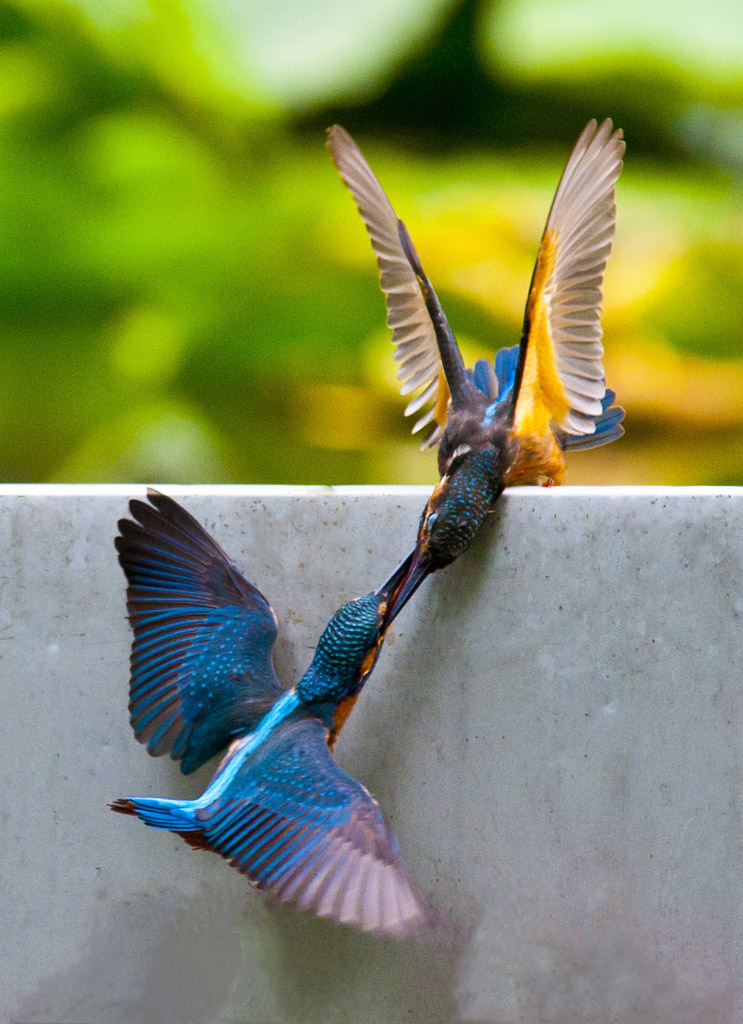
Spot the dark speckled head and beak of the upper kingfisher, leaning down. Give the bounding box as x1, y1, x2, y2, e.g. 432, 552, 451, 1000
385, 444, 505, 628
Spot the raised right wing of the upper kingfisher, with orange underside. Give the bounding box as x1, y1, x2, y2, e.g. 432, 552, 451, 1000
514, 119, 624, 435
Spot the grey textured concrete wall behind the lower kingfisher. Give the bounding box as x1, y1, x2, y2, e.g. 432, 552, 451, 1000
0, 487, 743, 1024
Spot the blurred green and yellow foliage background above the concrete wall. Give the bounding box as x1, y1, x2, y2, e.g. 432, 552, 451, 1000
0, 0, 743, 483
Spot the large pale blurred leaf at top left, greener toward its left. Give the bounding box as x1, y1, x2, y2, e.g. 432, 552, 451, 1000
46, 0, 451, 108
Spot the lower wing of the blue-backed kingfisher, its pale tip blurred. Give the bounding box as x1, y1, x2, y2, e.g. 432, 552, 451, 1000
197, 718, 428, 935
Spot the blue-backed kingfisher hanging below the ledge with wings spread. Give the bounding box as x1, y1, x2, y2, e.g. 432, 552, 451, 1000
110, 490, 431, 936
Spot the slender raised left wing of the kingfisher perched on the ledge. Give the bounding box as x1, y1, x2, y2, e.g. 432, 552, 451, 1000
327, 125, 449, 447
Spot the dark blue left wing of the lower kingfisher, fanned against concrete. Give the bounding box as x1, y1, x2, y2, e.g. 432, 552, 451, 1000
116, 490, 283, 774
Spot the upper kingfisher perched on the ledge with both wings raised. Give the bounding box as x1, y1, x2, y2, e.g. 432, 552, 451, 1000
327, 119, 624, 613
